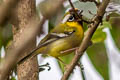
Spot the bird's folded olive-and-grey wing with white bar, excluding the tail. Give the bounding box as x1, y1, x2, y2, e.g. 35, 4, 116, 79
38, 24, 72, 46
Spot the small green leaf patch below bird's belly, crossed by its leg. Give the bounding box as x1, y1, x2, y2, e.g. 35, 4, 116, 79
58, 53, 74, 72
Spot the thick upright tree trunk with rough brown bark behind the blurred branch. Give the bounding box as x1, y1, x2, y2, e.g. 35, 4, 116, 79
11, 0, 38, 80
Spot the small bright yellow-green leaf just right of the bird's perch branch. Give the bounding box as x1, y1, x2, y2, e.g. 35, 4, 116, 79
92, 29, 106, 43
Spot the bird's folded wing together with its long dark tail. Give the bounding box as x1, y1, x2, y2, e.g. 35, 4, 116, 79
18, 24, 73, 64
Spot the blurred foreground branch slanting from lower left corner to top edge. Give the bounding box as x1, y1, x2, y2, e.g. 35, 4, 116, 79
0, 0, 64, 80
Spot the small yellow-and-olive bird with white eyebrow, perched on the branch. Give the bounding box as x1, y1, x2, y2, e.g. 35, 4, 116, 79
18, 9, 84, 63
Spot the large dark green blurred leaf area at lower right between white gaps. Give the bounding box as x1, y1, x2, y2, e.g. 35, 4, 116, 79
87, 43, 109, 80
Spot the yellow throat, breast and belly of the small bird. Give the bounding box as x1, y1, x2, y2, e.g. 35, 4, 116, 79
46, 22, 84, 57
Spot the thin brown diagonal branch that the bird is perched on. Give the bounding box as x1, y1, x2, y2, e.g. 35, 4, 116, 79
61, 0, 110, 80
